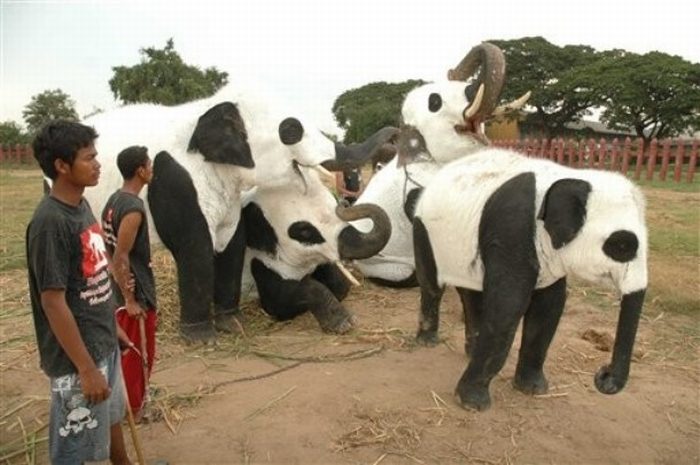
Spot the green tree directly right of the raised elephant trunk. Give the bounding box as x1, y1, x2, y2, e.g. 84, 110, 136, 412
489, 37, 600, 137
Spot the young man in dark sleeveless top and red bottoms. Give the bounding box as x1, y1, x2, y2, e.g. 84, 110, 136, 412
102, 146, 156, 418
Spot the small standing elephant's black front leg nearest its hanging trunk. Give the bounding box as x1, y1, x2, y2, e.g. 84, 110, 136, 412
513, 278, 566, 394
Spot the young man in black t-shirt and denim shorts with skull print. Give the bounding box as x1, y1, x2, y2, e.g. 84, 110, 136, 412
26, 120, 131, 465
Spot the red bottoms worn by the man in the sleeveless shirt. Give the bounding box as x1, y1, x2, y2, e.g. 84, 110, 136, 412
116, 307, 158, 415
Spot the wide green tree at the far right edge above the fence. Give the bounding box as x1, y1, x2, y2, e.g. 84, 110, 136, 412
569, 52, 700, 146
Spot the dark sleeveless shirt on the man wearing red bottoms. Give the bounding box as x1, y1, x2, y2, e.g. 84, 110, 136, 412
102, 190, 156, 309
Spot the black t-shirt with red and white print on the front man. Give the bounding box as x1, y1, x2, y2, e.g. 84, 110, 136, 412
26, 195, 117, 377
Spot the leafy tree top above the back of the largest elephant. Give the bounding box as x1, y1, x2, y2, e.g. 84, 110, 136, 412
109, 39, 228, 105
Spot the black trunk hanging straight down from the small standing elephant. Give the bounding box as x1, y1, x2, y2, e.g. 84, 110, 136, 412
595, 289, 646, 394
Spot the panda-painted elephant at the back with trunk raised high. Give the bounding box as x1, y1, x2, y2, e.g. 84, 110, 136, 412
357, 42, 529, 287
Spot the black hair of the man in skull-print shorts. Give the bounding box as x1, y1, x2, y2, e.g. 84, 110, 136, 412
32, 119, 98, 179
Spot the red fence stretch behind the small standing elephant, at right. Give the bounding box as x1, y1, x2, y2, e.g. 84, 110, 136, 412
494, 137, 700, 182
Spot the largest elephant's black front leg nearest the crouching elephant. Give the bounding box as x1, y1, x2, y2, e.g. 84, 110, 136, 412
214, 221, 245, 333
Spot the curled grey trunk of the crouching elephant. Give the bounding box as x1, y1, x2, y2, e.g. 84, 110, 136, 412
335, 204, 391, 260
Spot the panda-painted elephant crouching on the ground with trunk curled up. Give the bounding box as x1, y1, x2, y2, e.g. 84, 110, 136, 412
243, 169, 391, 333
